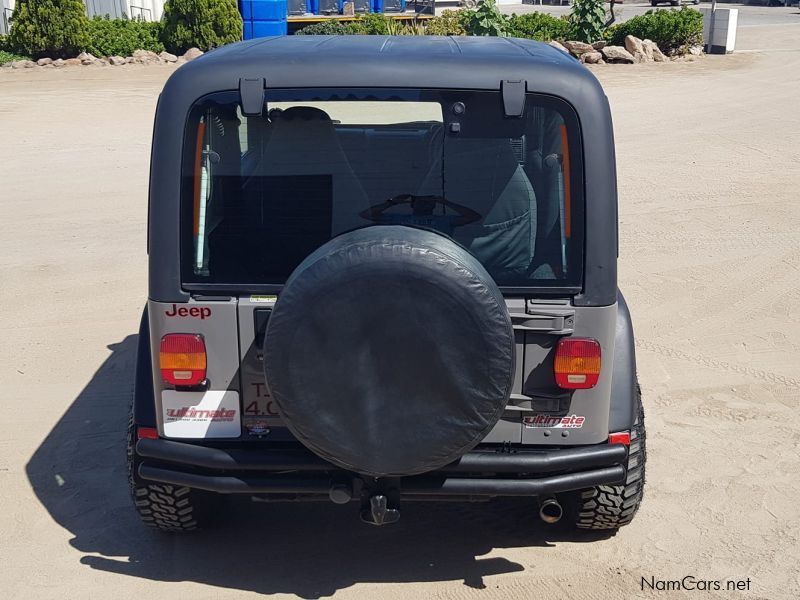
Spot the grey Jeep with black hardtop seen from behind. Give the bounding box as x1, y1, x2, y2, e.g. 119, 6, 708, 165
128, 36, 645, 531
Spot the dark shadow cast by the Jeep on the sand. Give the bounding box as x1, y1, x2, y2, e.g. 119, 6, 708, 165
26, 335, 605, 598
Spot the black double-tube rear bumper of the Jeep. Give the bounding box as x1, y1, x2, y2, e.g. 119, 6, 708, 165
136, 439, 628, 498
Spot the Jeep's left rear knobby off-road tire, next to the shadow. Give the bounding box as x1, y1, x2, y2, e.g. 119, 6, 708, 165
127, 416, 222, 533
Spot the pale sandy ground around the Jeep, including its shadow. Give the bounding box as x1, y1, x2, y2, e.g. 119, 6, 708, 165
0, 19, 800, 600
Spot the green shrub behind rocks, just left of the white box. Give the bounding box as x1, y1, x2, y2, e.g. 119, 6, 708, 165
609, 6, 703, 53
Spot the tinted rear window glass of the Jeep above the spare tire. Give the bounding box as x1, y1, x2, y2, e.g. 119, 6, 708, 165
181, 89, 583, 290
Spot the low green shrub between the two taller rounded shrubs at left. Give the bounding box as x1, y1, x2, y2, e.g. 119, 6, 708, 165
87, 17, 164, 56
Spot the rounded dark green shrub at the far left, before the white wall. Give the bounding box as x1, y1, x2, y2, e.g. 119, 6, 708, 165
8, 0, 89, 58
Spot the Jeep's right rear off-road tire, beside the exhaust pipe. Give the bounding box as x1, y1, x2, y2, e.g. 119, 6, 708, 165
571, 384, 647, 530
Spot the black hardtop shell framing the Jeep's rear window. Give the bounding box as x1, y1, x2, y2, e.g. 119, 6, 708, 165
149, 35, 617, 306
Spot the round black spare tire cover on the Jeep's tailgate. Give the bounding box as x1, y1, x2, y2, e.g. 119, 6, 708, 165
264, 225, 514, 477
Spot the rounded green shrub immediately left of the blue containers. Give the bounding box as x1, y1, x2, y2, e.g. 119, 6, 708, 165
161, 0, 242, 54
